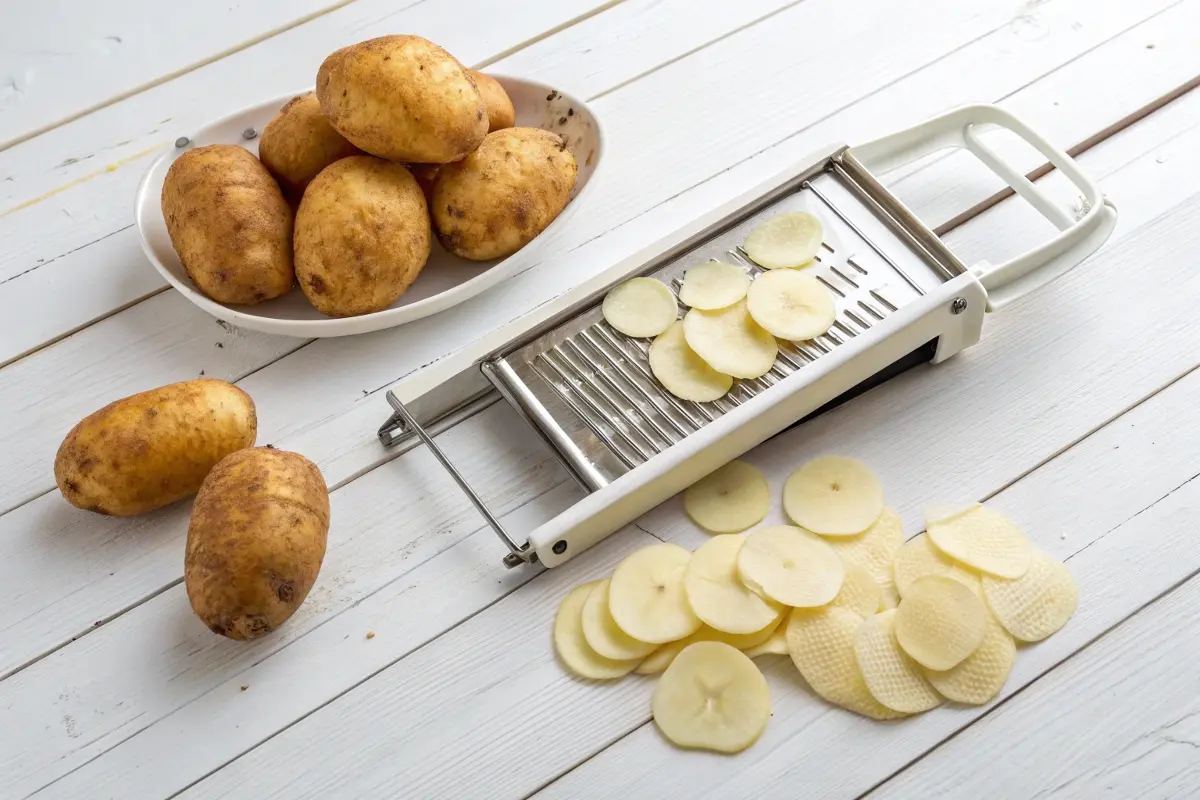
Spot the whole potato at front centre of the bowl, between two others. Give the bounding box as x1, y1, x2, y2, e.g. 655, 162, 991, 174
295, 156, 431, 317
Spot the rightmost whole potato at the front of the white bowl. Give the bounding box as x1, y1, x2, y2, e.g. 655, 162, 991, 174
432, 128, 578, 261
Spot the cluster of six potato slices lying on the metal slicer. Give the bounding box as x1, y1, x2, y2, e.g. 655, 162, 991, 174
602, 211, 836, 403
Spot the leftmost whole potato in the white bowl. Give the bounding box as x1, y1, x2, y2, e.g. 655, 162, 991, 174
162, 144, 295, 305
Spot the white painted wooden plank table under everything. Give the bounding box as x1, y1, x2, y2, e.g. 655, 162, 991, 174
0, 0, 1200, 799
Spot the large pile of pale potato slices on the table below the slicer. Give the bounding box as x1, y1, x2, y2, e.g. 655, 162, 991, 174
553, 456, 1079, 753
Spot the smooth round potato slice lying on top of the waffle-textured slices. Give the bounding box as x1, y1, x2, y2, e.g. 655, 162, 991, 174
895, 575, 988, 669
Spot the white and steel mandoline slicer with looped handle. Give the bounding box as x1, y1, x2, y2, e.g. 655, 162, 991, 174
379, 106, 1116, 566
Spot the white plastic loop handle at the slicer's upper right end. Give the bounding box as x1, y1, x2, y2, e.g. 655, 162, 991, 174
851, 100, 1117, 311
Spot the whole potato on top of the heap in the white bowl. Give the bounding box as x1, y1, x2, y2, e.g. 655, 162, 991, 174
317, 36, 487, 164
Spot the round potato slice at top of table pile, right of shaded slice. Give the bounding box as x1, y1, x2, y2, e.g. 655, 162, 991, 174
784, 456, 883, 536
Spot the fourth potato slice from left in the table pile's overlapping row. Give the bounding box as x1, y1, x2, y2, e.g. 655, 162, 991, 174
684, 534, 782, 633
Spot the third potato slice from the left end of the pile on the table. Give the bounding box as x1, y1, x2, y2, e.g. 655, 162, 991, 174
608, 543, 701, 643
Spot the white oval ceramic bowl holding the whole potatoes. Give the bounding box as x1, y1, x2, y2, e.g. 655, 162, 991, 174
134, 76, 604, 337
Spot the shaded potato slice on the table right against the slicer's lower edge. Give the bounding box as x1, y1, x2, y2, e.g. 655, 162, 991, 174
683, 461, 770, 534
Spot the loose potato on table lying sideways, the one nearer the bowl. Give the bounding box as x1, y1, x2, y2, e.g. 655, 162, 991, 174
54, 378, 258, 517
